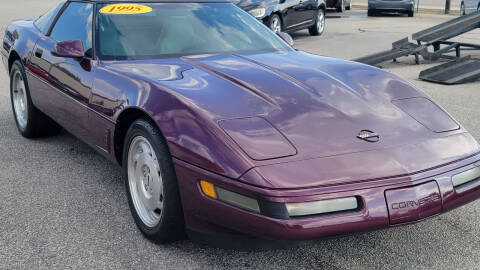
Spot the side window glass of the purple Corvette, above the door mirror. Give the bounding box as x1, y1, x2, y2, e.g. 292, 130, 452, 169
50, 2, 93, 57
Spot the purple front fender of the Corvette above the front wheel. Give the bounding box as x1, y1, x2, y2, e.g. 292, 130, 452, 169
91, 65, 253, 178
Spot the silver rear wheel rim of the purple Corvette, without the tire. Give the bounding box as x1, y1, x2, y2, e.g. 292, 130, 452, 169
12, 70, 28, 130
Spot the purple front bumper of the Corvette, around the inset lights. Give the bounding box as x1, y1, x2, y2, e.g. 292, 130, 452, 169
175, 155, 480, 241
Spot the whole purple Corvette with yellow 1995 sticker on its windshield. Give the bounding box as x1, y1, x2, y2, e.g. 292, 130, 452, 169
1, 0, 480, 247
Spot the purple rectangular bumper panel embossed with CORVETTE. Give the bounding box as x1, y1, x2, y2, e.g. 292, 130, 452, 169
385, 181, 442, 225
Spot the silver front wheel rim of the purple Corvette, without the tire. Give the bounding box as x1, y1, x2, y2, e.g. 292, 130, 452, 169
127, 136, 164, 228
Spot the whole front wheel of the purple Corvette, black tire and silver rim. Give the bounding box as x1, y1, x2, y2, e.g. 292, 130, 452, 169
122, 119, 185, 244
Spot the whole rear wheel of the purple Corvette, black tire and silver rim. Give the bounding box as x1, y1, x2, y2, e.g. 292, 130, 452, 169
10, 60, 62, 139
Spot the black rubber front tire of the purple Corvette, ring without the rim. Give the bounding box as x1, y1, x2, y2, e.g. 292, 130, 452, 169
122, 120, 183, 242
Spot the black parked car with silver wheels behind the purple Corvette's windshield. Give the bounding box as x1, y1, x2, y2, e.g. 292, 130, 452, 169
237, 0, 326, 36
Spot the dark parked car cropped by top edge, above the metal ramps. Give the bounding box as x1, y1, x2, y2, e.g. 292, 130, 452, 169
368, 0, 415, 17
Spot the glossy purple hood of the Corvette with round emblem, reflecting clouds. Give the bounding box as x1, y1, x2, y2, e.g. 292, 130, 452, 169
102, 51, 476, 186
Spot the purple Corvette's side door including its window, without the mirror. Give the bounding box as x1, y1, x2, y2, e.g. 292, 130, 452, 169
30, 2, 95, 140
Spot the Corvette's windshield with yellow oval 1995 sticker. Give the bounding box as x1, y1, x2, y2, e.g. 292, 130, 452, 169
96, 3, 292, 60
